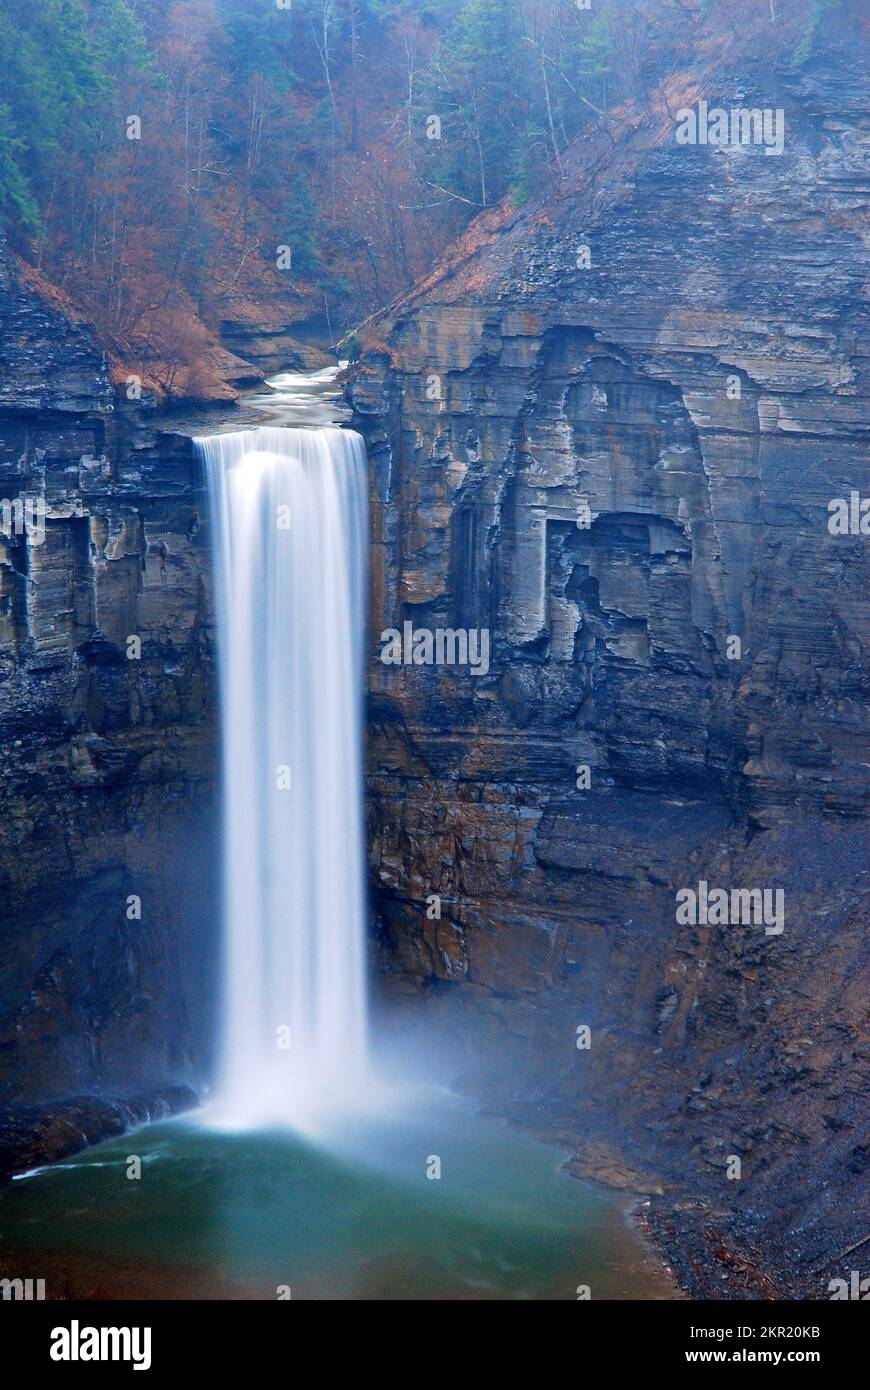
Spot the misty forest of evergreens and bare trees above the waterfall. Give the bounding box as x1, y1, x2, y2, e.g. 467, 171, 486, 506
0, 0, 837, 391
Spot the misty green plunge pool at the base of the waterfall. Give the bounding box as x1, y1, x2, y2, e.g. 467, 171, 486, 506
0, 1095, 671, 1300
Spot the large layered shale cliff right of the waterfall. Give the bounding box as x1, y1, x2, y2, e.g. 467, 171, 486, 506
352, 35, 870, 1297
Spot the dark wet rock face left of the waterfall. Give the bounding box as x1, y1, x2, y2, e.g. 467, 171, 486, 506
0, 241, 215, 1101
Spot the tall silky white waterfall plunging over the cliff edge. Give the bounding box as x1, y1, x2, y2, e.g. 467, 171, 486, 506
196, 427, 367, 1127
